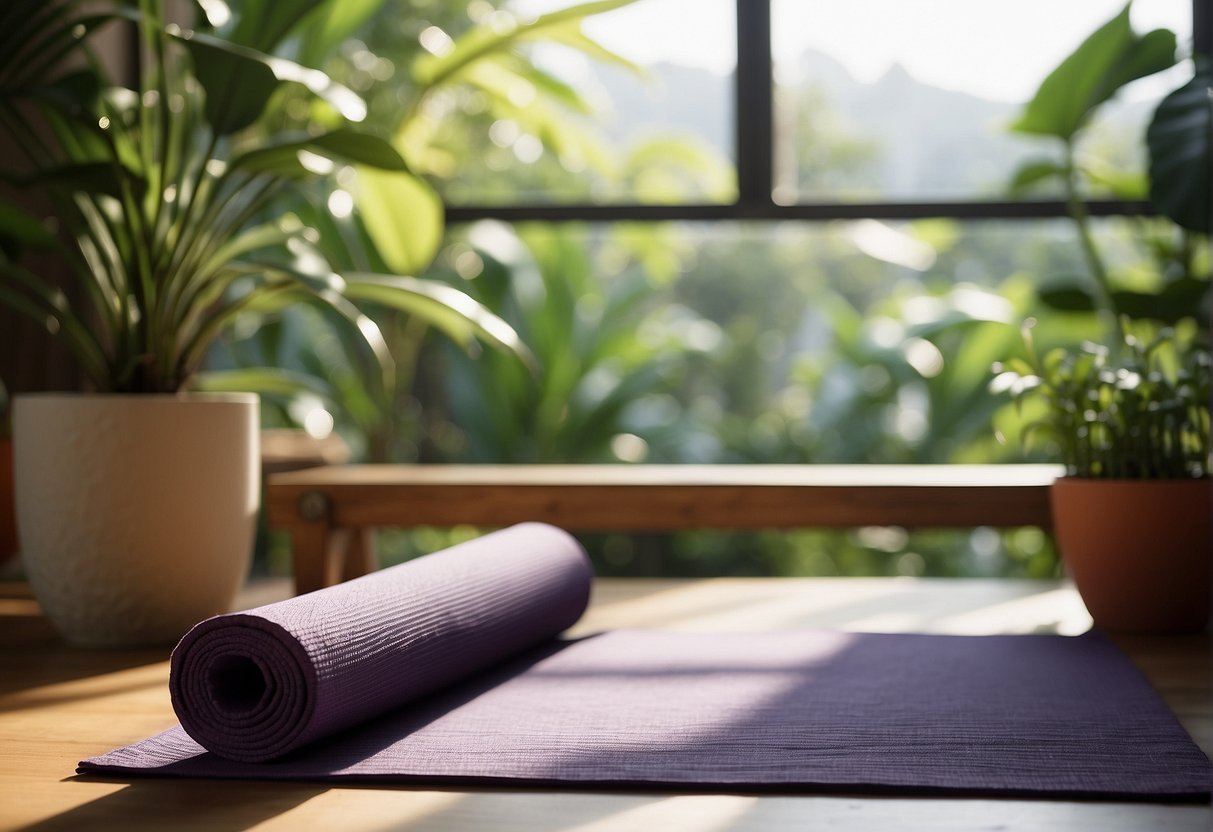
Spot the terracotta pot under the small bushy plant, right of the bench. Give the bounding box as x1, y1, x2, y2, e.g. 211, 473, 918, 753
1050, 477, 1213, 633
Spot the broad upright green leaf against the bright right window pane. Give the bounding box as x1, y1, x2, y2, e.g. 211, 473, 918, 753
1012, 4, 1175, 141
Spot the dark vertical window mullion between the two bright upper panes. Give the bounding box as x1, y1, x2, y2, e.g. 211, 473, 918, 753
734, 0, 774, 206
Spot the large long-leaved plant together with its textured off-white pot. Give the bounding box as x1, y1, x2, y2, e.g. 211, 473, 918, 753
0, 0, 524, 645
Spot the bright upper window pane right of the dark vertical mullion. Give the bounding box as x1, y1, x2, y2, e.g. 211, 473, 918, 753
771, 0, 1191, 203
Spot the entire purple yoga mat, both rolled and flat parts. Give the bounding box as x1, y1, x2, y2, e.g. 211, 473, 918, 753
79, 524, 1213, 800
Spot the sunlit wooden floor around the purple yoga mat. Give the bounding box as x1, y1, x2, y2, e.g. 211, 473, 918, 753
0, 579, 1213, 832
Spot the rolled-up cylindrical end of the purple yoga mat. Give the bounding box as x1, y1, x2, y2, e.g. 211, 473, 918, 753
169, 524, 592, 763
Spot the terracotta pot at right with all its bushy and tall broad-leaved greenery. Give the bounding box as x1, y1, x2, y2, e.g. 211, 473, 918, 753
995, 6, 1213, 632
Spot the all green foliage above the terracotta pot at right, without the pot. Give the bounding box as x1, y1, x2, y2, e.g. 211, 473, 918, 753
993, 4, 1213, 479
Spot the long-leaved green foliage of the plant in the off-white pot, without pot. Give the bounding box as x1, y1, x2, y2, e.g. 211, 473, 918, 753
0, 0, 524, 392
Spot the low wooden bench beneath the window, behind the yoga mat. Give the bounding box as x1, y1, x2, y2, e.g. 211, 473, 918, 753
266, 465, 1060, 593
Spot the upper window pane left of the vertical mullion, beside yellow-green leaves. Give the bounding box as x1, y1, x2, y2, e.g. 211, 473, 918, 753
432, 0, 736, 205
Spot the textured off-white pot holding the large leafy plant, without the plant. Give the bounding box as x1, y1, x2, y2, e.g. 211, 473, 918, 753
13, 393, 260, 646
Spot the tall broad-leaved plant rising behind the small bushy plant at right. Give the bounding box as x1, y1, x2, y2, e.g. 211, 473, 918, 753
1012, 2, 1213, 337
